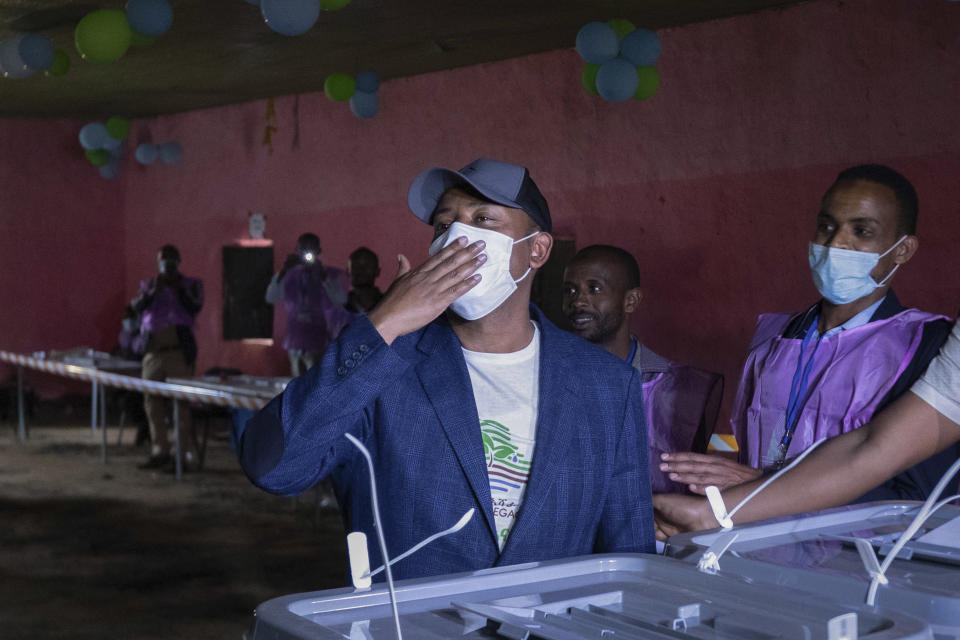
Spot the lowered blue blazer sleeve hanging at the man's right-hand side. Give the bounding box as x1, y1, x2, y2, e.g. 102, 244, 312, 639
595, 371, 655, 553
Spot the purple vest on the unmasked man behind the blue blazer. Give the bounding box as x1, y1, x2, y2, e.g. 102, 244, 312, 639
641, 362, 720, 493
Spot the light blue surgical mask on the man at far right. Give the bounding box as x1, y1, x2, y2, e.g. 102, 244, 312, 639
810, 236, 907, 304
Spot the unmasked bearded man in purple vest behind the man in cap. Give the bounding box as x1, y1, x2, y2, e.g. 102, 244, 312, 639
562, 244, 723, 493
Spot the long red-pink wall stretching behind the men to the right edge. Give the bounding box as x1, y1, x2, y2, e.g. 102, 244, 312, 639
0, 0, 960, 416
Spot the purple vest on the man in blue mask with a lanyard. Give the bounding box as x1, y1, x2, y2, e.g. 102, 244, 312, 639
730, 309, 944, 468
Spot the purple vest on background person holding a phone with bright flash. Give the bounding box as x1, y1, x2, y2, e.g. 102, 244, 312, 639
283, 265, 353, 352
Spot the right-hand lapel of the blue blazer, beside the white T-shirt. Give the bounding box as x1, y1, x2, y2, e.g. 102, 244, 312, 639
500, 307, 576, 563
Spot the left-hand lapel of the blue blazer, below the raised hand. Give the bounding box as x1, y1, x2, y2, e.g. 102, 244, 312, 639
415, 321, 497, 545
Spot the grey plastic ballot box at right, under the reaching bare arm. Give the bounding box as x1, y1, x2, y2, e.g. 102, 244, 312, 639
666, 502, 960, 640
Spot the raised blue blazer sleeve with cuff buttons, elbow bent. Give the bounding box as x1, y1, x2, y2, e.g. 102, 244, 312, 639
239, 317, 411, 496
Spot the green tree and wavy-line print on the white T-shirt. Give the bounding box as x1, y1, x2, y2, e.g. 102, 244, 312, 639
480, 420, 533, 549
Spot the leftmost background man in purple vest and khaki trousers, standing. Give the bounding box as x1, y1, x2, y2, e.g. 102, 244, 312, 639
130, 244, 203, 470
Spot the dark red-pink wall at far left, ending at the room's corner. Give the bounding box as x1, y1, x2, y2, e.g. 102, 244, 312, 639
0, 116, 126, 395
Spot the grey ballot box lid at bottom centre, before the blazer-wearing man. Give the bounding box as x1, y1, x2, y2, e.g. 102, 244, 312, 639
246, 554, 931, 640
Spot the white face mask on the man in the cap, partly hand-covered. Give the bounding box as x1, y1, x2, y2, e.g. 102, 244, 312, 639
430, 222, 540, 320
